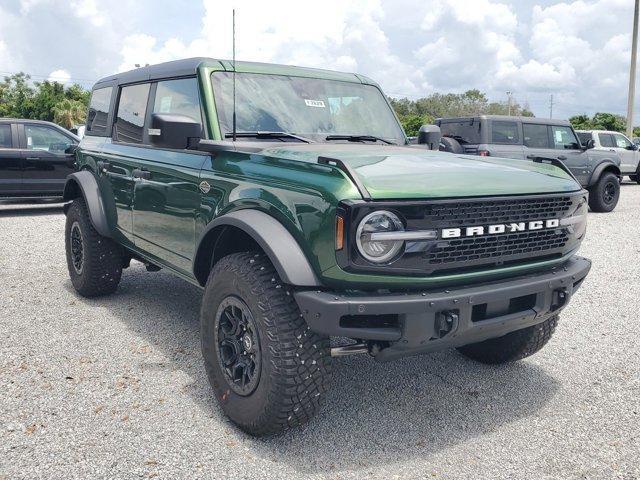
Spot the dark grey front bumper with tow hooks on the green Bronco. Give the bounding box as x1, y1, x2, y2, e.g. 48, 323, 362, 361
294, 256, 591, 361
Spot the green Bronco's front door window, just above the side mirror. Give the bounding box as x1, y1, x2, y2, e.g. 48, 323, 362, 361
153, 78, 202, 123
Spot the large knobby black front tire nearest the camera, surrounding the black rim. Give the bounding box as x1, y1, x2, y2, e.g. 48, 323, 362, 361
200, 252, 331, 436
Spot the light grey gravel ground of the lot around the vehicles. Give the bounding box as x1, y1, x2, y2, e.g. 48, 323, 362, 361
0, 188, 640, 479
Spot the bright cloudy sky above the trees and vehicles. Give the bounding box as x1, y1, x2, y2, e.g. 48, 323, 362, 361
0, 0, 640, 120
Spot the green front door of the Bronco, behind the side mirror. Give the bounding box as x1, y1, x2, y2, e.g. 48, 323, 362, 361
133, 78, 210, 274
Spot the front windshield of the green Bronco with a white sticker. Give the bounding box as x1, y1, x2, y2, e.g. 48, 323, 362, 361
211, 72, 405, 143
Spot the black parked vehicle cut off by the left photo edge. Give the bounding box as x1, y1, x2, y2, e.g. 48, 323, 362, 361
0, 118, 80, 200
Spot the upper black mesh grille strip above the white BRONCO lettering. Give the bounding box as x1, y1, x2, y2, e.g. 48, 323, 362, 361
424, 196, 573, 228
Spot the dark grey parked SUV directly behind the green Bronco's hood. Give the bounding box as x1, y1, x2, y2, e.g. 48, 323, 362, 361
436, 115, 622, 212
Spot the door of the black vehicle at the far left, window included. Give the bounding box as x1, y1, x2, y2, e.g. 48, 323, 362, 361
18, 123, 77, 195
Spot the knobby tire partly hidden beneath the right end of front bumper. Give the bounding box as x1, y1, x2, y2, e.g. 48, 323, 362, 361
458, 315, 558, 364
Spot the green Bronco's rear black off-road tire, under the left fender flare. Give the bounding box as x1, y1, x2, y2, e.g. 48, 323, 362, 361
64, 198, 123, 297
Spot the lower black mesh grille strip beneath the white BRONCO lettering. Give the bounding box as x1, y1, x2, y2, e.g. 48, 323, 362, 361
426, 229, 569, 265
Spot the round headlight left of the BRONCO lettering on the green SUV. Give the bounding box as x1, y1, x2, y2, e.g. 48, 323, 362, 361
356, 210, 404, 263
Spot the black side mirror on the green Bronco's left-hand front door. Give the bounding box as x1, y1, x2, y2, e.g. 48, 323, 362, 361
149, 113, 202, 150
